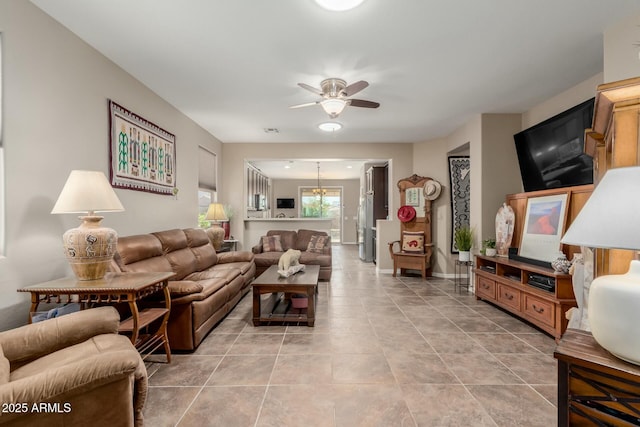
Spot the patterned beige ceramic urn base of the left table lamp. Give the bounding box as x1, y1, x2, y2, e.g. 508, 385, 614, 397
62, 216, 118, 280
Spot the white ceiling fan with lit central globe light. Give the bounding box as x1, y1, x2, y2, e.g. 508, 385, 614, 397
289, 78, 380, 119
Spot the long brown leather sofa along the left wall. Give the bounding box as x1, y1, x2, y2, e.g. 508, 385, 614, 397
111, 228, 256, 350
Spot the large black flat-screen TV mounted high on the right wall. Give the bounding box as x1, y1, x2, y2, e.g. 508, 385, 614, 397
513, 98, 595, 191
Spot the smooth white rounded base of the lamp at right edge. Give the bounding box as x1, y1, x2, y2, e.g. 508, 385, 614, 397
589, 260, 640, 365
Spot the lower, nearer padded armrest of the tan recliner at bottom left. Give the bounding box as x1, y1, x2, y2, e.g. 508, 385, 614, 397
0, 348, 147, 424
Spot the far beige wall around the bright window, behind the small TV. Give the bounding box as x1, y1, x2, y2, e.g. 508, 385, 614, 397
271, 179, 360, 243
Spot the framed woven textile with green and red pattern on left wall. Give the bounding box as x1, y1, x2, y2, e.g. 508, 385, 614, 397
109, 101, 176, 195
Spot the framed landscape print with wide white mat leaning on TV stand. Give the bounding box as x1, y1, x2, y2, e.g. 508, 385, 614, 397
518, 193, 568, 262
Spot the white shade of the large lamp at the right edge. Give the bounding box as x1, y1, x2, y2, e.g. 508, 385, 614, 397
561, 167, 640, 250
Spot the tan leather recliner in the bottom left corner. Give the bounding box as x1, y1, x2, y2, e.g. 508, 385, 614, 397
0, 307, 147, 427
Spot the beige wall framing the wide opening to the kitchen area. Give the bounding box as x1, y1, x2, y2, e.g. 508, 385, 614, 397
218, 143, 413, 252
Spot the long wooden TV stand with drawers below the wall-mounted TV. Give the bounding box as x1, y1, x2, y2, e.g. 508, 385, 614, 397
473, 255, 576, 341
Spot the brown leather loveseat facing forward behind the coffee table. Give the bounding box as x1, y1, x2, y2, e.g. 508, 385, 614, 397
251, 229, 331, 280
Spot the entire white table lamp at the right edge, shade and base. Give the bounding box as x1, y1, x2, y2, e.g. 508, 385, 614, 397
561, 167, 640, 365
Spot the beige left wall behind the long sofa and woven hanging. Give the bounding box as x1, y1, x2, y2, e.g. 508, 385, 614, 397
0, 0, 221, 330
